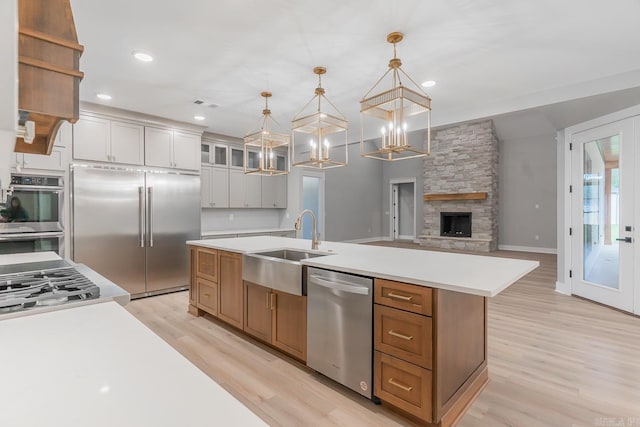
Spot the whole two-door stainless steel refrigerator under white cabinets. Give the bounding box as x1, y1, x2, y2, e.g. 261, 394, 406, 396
71, 165, 200, 296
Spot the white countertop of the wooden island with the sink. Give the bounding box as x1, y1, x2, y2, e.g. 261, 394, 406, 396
187, 236, 540, 297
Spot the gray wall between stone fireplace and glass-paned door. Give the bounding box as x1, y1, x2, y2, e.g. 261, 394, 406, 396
498, 131, 557, 249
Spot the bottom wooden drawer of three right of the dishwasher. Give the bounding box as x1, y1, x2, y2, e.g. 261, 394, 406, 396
373, 351, 433, 422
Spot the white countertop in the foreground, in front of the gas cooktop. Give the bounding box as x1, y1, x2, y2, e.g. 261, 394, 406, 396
0, 302, 266, 427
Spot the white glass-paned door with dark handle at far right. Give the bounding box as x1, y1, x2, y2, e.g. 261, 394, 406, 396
571, 119, 640, 312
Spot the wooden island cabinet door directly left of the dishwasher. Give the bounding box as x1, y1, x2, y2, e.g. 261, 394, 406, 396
271, 291, 307, 361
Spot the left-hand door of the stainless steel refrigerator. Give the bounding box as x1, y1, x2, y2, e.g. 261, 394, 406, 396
72, 166, 145, 294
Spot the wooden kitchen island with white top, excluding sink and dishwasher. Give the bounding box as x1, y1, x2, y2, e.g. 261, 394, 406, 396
187, 237, 538, 427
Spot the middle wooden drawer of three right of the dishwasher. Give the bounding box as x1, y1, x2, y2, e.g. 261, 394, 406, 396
373, 304, 433, 369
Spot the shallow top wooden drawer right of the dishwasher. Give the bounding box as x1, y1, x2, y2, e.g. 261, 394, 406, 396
374, 279, 433, 316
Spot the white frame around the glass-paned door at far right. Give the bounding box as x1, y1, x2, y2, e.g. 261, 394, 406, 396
556, 105, 640, 314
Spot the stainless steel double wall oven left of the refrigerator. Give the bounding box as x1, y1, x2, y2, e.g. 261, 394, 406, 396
0, 174, 64, 255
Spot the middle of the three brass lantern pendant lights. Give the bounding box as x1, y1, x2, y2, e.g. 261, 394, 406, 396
291, 67, 348, 169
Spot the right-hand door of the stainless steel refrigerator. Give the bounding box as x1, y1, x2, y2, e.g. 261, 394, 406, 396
146, 172, 200, 292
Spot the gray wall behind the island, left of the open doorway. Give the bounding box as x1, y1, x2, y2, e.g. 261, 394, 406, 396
324, 144, 383, 241
